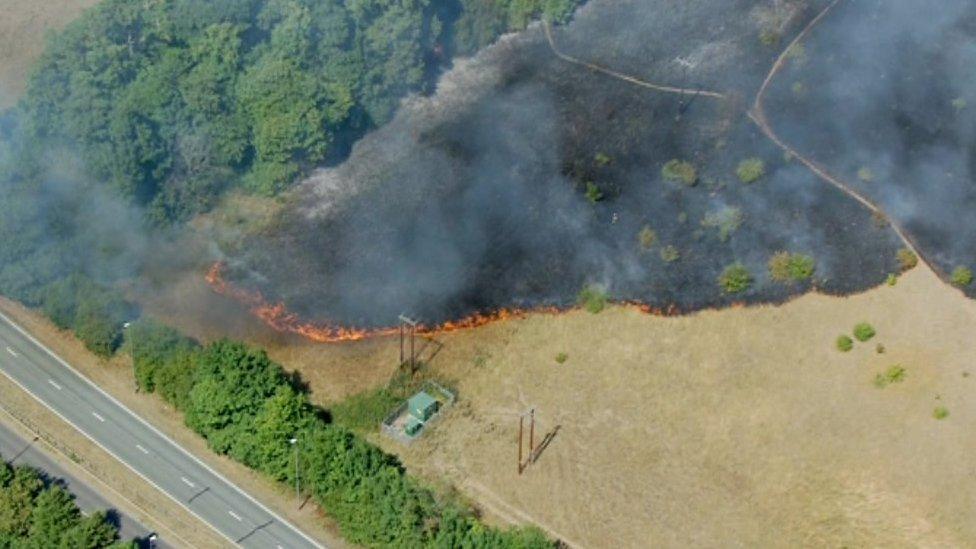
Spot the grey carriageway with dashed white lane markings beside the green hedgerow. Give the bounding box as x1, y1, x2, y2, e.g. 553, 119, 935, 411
0, 314, 323, 549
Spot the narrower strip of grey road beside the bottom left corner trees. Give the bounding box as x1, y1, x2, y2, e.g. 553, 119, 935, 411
0, 424, 160, 547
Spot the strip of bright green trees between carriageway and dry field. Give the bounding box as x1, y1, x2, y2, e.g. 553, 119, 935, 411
125, 321, 553, 549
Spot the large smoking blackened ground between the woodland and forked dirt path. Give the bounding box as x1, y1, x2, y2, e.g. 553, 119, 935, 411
230, 0, 908, 326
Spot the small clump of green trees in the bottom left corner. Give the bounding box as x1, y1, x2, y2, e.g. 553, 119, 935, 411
0, 461, 136, 549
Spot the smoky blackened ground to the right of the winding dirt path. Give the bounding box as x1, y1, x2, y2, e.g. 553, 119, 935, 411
767, 0, 976, 295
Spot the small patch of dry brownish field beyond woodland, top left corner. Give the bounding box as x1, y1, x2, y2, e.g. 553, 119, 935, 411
0, 0, 98, 109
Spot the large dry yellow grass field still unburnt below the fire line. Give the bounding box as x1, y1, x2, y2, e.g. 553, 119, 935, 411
368, 268, 976, 547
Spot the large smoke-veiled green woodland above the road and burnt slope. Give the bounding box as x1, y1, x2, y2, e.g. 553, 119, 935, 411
0, 0, 579, 356
